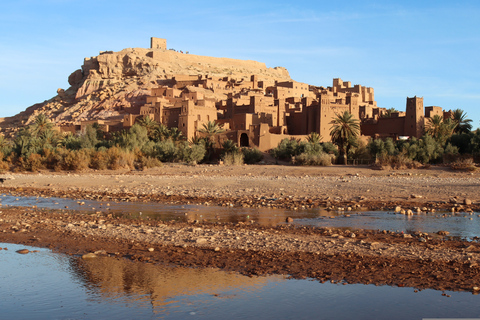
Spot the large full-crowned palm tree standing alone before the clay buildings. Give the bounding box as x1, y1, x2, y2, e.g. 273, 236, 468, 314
330, 111, 360, 164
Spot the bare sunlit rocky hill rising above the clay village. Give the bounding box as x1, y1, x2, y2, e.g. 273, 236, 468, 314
0, 48, 290, 134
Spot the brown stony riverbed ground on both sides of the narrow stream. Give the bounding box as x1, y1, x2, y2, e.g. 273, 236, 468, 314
0, 164, 480, 293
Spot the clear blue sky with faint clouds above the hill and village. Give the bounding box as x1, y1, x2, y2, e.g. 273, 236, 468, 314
0, 0, 480, 128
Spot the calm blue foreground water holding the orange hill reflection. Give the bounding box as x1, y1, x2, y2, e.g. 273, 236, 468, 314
0, 244, 480, 319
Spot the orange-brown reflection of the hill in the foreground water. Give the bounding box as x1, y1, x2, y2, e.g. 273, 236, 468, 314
70, 257, 284, 312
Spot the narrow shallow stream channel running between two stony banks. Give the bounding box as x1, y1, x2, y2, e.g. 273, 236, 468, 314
0, 194, 480, 239
